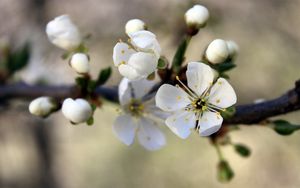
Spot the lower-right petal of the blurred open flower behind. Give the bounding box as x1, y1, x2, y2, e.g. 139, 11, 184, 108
137, 118, 166, 150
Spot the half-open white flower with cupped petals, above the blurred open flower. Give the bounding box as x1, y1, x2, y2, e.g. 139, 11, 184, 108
113, 31, 161, 80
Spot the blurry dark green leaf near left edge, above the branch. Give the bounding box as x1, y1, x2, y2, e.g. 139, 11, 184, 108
6, 43, 30, 74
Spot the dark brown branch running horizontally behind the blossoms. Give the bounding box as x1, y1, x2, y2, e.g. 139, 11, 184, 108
0, 80, 300, 125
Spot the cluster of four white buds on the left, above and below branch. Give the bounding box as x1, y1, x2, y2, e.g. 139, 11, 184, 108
29, 15, 93, 124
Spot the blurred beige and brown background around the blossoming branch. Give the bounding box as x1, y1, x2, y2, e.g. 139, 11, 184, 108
0, 0, 300, 188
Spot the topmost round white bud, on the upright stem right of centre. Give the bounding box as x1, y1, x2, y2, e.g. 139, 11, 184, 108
184, 5, 209, 29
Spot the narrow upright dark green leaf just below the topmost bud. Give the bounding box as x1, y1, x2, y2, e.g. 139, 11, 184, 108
172, 36, 191, 73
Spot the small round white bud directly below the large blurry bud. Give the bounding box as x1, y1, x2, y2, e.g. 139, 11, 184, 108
70, 53, 90, 74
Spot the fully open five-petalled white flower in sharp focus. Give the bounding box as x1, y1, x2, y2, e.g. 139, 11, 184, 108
155, 62, 236, 139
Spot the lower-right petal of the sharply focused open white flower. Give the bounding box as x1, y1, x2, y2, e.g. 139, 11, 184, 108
199, 111, 223, 136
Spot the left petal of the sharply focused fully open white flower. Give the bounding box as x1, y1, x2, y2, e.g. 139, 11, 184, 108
155, 84, 190, 111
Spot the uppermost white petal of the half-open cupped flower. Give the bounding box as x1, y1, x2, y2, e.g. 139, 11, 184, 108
129, 30, 161, 58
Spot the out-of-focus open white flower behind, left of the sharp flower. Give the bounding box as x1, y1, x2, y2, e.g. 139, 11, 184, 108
113, 78, 166, 150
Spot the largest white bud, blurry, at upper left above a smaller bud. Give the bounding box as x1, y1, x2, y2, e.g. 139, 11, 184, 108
46, 15, 82, 51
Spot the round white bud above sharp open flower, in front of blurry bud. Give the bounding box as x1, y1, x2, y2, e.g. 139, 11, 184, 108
205, 39, 229, 64
